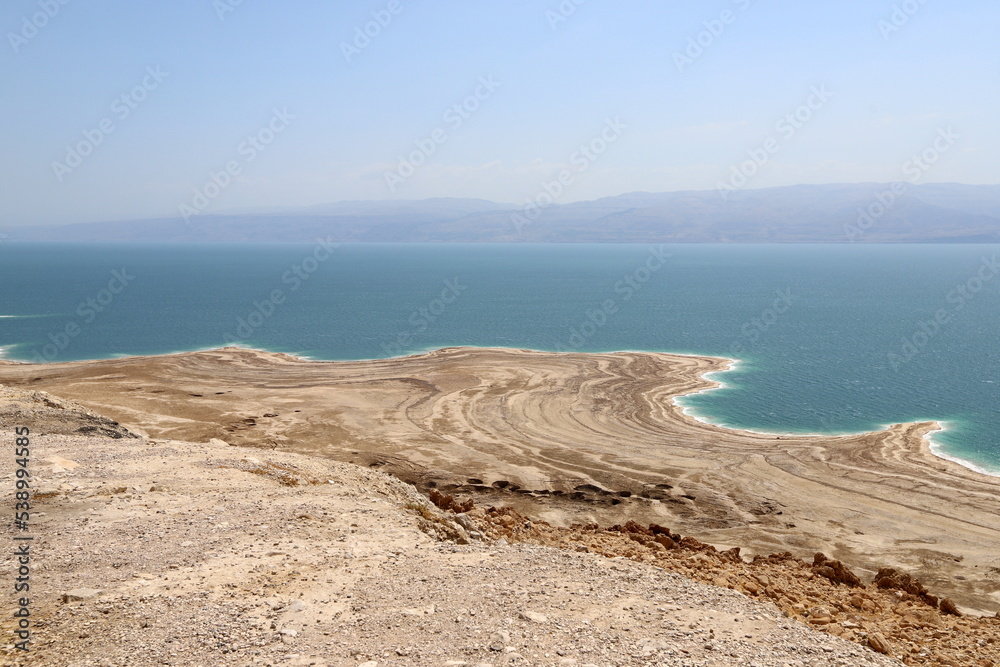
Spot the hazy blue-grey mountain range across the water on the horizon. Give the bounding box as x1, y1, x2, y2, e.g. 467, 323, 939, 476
2, 183, 1000, 243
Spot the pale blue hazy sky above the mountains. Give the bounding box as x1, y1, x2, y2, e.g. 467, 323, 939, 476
0, 0, 1000, 227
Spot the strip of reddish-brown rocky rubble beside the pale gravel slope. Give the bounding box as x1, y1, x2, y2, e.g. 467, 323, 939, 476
456, 500, 1000, 667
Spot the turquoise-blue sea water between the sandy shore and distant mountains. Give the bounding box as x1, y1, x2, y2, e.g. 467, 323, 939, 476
0, 243, 1000, 474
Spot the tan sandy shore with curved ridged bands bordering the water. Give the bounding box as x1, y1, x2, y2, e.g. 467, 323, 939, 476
0, 348, 1000, 614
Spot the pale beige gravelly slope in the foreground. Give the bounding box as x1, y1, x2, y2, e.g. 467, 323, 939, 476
0, 387, 899, 667
